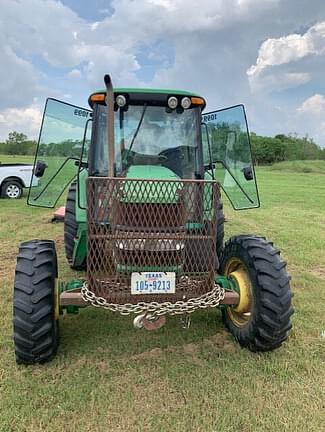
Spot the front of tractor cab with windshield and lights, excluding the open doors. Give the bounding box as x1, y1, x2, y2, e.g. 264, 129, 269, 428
89, 89, 204, 179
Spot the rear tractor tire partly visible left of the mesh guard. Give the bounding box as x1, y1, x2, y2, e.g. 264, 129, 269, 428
64, 182, 86, 270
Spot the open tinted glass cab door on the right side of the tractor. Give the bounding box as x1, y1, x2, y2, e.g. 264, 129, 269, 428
202, 105, 260, 210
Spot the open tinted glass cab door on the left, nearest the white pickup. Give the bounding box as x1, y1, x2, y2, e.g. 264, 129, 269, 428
27, 98, 91, 208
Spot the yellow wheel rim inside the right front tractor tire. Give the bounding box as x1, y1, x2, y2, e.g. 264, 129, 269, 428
224, 257, 253, 327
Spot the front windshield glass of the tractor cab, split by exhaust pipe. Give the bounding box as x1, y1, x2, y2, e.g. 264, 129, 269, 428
91, 105, 201, 179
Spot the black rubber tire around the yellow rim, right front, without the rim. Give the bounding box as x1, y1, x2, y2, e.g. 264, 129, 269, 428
221, 235, 294, 351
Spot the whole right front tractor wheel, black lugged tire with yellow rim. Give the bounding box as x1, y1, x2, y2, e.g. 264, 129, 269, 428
220, 235, 293, 351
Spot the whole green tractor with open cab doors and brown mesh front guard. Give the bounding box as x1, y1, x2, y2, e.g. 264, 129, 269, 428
13, 75, 293, 364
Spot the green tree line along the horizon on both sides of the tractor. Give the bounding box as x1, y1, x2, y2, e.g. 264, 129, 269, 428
0, 129, 325, 165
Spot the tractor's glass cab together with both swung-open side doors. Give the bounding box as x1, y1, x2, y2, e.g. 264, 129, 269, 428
28, 88, 259, 210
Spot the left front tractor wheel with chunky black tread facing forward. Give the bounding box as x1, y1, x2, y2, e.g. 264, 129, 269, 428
13, 240, 59, 364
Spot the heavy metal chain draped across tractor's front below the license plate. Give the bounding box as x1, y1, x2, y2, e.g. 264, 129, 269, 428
81, 281, 225, 316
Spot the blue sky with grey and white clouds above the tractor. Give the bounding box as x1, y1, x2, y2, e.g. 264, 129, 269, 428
0, 0, 325, 147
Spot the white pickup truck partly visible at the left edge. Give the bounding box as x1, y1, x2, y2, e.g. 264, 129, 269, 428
0, 162, 38, 199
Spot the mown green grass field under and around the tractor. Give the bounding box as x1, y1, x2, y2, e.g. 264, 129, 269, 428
0, 162, 325, 432
